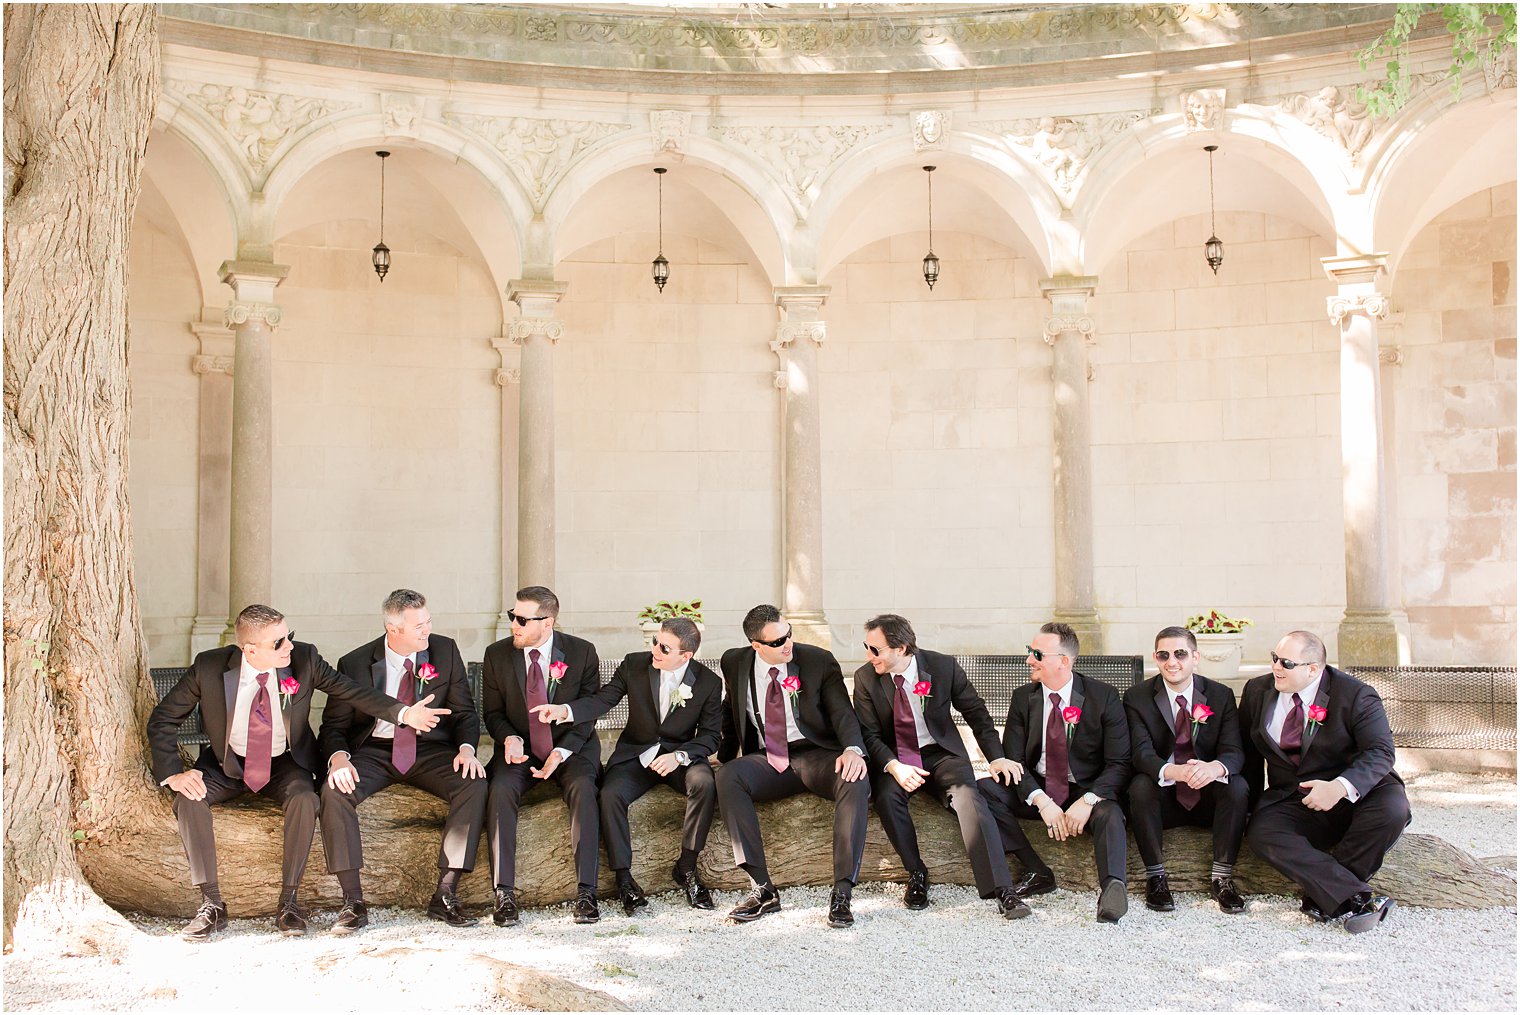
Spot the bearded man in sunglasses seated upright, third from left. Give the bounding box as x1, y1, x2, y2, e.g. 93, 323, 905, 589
480, 585, 602, 927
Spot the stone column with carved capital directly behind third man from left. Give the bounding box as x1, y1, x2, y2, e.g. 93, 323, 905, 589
497, 278, 570, 595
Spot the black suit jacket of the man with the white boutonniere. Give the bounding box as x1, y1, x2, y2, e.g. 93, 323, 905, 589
570, 652, 724, 767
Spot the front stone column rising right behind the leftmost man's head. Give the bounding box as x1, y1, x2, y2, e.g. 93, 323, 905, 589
220, 261, 290, 638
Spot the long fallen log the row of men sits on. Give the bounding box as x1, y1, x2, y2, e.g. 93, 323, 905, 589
91, 768, 1515, 916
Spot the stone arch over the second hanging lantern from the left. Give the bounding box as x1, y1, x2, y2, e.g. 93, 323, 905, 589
543, 132, 800, 284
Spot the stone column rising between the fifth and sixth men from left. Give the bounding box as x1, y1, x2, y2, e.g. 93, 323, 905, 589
771, 286, 833, 649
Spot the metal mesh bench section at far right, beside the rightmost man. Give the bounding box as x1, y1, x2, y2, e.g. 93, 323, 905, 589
1350, 666, 1515, 751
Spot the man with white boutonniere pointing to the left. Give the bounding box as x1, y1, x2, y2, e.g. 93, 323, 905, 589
534, 617, 724, 916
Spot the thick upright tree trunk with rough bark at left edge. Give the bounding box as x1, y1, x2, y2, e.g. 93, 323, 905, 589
5, 5, 167, 950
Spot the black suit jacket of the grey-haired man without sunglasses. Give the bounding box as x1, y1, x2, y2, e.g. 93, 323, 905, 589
316, 635, 480, 761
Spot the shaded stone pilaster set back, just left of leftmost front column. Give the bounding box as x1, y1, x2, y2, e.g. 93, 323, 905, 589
190, 313, 234, 658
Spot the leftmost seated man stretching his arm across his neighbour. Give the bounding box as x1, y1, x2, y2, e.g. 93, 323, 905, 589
147, 605, 448, 941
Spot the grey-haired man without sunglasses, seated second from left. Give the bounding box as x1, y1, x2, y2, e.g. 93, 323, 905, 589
318, 588, 485, 934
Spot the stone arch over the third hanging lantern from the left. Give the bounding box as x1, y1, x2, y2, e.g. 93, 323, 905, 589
809, 134, 1070, 277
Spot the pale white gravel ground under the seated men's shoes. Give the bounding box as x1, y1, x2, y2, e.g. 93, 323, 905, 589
5, 773, 1517, 1012
